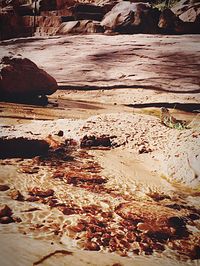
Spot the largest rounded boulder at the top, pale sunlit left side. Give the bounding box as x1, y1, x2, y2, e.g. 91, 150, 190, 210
101, 1, 160, 33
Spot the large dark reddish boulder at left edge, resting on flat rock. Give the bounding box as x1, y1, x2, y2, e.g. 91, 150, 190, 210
0, 56, 58, 99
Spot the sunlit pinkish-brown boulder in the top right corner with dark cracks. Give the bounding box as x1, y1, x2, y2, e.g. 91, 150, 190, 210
172, 0, 200, 22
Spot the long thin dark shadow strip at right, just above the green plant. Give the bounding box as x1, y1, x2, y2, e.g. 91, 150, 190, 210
125, 102, 200, 112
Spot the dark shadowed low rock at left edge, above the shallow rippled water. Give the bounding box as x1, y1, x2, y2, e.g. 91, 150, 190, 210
0, 137, 49, 158
